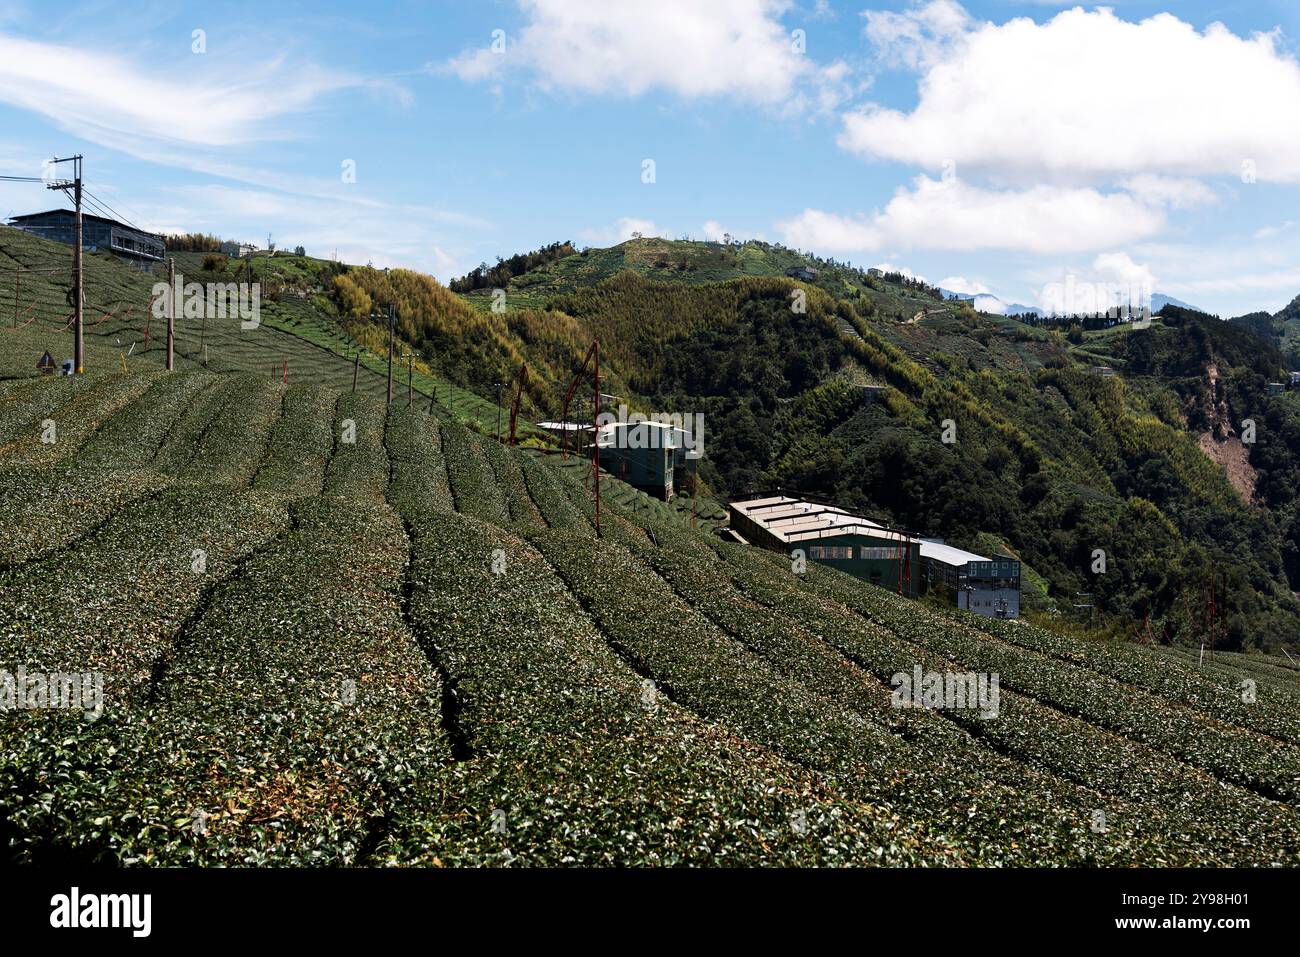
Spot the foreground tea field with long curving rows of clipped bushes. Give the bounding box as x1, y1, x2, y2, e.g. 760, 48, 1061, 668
0, 365, 1300, 867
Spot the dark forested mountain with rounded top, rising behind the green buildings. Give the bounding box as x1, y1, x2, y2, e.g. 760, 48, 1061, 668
418, 239, 1300, 648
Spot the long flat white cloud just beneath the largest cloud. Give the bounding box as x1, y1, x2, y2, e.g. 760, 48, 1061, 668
777, 176, 1165, 254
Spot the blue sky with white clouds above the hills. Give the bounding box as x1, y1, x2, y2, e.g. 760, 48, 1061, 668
0, 0, 1300, 315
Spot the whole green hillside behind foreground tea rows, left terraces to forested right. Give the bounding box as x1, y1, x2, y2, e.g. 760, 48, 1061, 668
0, 230, 1300, 650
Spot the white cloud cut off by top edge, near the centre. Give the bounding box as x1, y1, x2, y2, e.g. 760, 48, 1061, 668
443, 0, 815, 104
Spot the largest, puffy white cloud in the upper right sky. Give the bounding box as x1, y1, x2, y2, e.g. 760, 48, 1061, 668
840, 0, 1300, 182
